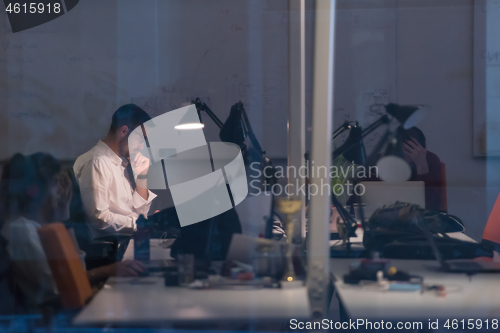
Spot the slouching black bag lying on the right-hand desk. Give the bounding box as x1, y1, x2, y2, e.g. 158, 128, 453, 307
363, 202, 493, 260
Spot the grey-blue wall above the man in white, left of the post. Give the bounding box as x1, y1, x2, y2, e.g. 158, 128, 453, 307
0, 0, 288, 159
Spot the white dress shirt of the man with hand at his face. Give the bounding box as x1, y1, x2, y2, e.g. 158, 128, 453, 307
73, 140, 156, 238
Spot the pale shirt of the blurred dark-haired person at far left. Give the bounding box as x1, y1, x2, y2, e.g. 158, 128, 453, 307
2, 216, 58, 305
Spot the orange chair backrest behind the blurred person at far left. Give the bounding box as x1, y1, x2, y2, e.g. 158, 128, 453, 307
38, 223, 92, 308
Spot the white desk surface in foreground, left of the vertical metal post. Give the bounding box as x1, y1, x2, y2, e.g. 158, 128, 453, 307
74, 277, 310, 326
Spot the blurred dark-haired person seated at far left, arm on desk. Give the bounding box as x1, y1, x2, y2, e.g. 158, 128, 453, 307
0, 153, 144, 309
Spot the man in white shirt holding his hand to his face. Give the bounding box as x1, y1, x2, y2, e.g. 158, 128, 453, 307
73, 104, 156, 238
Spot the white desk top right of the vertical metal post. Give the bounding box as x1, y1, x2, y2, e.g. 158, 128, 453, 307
330, 233, 500, 321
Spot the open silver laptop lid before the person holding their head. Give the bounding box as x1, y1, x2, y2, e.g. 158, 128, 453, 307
360, 181, 425, 219
